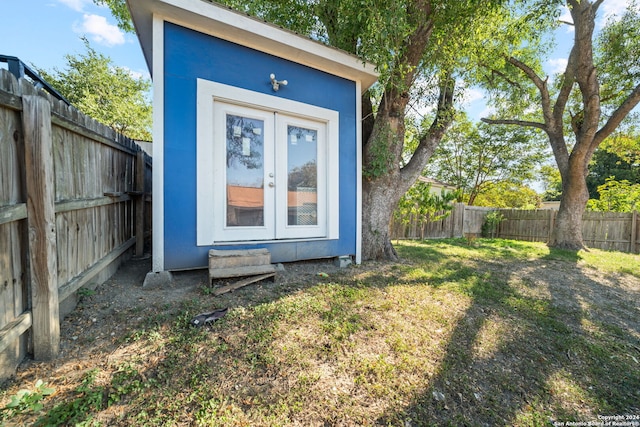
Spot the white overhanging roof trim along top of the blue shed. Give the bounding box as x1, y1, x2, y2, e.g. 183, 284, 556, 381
127, 0, 378, 90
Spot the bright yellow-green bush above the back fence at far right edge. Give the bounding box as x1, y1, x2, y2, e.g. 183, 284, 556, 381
587, 177, 640, 212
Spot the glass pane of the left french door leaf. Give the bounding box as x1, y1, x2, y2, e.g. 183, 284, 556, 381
226, 114, 264, 227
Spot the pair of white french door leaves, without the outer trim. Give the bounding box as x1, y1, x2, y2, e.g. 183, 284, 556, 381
213, 102, 327, 241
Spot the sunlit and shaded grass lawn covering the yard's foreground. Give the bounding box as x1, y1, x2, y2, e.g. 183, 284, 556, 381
0, 239, 640, 427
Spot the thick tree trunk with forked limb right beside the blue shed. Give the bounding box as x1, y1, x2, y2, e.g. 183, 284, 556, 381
362, 0, 446, 261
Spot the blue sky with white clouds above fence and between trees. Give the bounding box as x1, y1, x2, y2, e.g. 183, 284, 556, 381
0, 0, 631, 120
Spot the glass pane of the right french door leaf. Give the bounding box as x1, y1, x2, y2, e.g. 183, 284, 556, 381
287, 125, 318, 225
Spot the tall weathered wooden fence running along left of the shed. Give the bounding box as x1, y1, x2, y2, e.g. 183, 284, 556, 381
0, 69, 151, 379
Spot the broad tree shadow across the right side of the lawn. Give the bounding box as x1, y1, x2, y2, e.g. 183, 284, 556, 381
377, 242, 640, 426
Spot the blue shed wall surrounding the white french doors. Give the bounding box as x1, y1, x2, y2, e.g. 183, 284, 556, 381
164, 22, 358, 270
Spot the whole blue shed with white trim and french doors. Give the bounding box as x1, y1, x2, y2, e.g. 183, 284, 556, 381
128, 0, 377, 272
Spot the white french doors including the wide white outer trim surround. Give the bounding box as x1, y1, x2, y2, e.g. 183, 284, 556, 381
196, 79, 340, 246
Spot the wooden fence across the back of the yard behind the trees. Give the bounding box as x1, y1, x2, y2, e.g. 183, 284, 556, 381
391, 203, 640, 253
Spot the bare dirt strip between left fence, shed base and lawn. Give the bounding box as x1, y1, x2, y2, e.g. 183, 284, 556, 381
12, 259, 344, 376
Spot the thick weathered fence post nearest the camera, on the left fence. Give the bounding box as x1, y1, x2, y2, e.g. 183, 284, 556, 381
22, 95, 60, 360
